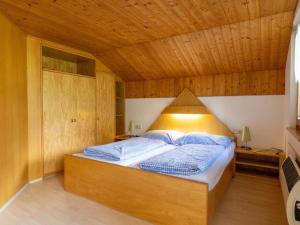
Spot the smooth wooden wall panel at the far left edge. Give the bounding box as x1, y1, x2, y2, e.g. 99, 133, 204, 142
0, 13, 28, 206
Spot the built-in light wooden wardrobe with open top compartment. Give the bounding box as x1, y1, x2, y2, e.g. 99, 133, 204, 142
27, 36, 125, 181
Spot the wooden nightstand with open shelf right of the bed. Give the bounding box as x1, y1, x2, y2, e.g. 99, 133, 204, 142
235, 147, 285, 177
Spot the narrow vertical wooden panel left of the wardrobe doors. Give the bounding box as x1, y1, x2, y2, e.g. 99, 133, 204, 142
27, 36, 43, 180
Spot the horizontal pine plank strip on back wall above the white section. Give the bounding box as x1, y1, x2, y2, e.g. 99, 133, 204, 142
126, 70, 285, 98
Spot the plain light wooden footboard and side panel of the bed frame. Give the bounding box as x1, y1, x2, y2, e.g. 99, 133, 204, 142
64, 155, 233, 225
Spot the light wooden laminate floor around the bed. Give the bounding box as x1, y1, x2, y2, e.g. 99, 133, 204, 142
0, 174, 287, 225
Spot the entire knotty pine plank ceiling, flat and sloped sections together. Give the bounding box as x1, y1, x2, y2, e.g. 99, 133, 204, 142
0, 0, 297, 81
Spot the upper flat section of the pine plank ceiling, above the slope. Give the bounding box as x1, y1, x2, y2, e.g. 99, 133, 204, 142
0, 0, 297, 52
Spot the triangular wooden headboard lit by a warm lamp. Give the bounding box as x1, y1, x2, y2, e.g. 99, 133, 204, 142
149, 89, 235, 138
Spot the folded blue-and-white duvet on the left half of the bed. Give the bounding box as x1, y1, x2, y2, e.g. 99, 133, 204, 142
83, 137, 166, 161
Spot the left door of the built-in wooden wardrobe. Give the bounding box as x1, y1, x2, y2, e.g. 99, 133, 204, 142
43, 71, 77, 175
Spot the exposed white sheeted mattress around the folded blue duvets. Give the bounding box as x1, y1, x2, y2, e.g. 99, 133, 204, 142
73, 143, 235, 190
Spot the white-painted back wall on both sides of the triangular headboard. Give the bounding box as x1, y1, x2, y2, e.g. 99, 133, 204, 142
126, 95, 284, 148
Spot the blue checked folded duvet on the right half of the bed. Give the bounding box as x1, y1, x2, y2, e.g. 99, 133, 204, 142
139, 144, 225, 176
